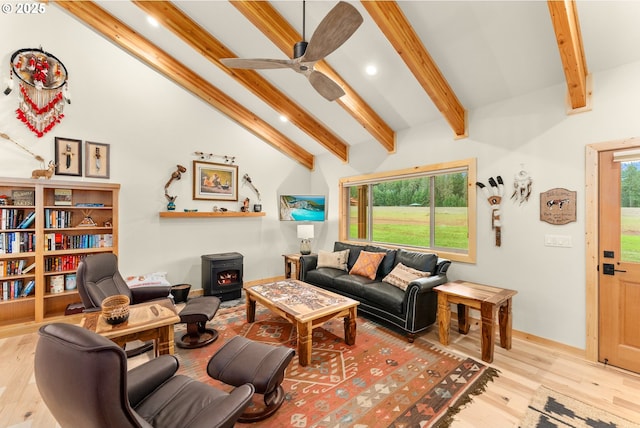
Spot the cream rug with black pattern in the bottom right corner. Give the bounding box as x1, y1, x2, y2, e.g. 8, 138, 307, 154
520, 386, 640, 428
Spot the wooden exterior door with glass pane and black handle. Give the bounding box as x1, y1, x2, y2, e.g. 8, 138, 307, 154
598, 150, 640, 372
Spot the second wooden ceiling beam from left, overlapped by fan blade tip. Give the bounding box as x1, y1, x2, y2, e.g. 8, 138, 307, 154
133, 1, 349, 162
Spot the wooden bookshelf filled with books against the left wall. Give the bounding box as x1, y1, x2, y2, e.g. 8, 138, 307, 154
0, 178, 120, 335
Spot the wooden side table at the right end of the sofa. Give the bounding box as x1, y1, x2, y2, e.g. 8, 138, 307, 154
433, 281, 518, 363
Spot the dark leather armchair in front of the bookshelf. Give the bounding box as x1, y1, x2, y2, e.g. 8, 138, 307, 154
76, 253, 171, 311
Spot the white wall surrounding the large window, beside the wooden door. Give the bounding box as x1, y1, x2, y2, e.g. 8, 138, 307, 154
312, 63, 640, 348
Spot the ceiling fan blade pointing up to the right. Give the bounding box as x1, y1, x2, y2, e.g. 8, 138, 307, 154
303, 1, 362, 62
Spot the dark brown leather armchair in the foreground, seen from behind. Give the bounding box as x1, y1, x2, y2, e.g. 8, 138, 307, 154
34, 323, 254, 428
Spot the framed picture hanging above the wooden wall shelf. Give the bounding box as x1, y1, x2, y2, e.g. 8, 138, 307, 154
193, 161, 238, 201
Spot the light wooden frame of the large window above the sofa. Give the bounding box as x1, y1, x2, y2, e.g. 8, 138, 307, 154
338, 158, 477, 263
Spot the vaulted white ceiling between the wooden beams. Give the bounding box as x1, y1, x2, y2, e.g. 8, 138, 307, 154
56, 0, 640, 167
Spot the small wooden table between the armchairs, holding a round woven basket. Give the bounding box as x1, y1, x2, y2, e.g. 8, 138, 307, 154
80, 299, 180, 357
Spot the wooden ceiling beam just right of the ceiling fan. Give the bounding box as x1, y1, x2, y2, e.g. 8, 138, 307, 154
361, 0, 467, 138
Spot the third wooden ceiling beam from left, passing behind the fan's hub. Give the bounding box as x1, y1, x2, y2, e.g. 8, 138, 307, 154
230, 0, 396, 153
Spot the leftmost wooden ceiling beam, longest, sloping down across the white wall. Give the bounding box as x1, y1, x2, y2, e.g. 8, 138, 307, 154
55, 0, 314, 169
